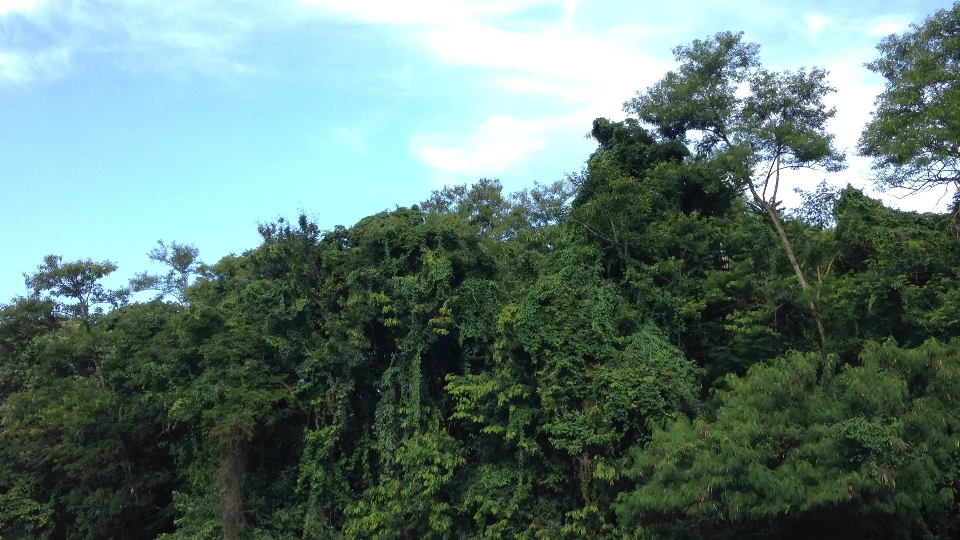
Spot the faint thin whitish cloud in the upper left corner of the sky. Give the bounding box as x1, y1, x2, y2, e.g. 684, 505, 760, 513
0, 0, 280, 83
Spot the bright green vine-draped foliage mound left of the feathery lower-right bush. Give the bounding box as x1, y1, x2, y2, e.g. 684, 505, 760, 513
446, 248, 697, 538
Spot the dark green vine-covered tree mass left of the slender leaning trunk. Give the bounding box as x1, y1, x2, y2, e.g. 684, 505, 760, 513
570, 119, 832, 380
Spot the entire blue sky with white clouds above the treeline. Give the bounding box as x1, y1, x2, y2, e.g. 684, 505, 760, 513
0, 0, 951, 302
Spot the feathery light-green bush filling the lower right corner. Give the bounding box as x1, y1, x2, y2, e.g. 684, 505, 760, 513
617, 340, 960, 537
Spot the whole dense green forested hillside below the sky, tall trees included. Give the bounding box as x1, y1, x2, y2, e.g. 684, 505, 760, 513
0, 6, 960, 540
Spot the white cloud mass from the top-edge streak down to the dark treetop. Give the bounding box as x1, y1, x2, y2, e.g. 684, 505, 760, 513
300, 0, 669, 180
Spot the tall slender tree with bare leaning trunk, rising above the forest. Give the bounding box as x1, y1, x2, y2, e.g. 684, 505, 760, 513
624, 32, 844, 346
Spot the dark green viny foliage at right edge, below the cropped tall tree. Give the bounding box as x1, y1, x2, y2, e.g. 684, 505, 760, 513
822, 188, 960, 354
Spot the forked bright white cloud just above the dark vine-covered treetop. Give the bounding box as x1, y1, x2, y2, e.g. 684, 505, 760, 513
411, 19, 668, 173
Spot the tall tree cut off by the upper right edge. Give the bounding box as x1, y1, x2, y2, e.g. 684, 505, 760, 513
857, 3, 960, 202
